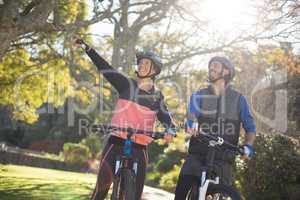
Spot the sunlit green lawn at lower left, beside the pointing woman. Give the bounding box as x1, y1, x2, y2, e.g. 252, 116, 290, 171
0, 165, 96, 200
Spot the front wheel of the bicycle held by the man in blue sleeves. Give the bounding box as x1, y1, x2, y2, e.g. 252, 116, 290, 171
205, 184, 242, 200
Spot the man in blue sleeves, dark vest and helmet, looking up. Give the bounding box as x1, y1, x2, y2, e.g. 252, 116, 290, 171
175, 56, 256, 200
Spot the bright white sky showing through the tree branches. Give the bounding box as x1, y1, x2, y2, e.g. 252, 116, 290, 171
85, 0, 299, 68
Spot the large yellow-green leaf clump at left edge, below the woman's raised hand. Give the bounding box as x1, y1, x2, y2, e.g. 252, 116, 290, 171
0, 49, 72, 123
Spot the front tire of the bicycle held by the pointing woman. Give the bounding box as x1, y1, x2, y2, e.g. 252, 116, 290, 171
111, 169, 136, 200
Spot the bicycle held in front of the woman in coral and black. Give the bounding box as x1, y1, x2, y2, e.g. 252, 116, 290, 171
97, 125, 164, 200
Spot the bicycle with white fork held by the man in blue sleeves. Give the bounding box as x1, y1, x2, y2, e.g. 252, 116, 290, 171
187, 130, 244, 200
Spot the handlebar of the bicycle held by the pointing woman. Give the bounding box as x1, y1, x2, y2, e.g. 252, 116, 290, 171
93, 124, 165, 140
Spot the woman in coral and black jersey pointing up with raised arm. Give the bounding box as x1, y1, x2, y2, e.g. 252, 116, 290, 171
75, 38, 175, 200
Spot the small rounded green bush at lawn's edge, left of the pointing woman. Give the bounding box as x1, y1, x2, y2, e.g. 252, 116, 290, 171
63, 143, 91, 166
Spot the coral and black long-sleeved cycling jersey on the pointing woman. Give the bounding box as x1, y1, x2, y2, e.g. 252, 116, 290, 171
87, 49, 175, 145
